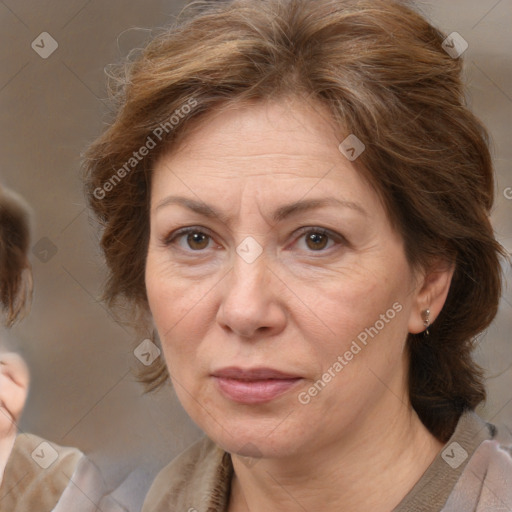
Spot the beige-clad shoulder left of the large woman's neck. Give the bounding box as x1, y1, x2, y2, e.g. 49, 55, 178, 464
142, 437, 231, 512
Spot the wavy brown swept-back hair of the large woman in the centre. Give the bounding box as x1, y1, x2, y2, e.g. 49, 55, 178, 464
84, 0, 504, 440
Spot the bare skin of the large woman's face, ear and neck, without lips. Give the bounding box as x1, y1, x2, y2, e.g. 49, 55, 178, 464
145, 98, 452, 512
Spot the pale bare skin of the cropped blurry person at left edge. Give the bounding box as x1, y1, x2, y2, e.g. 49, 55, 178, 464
0, 352, 29, 484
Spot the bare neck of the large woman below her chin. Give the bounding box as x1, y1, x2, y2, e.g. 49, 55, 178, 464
228, 394, 443, 512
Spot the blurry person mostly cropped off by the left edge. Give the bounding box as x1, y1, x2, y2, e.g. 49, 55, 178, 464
0, 186, 124, 512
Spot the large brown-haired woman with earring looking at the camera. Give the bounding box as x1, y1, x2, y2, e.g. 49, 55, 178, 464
85, 0, 512, 512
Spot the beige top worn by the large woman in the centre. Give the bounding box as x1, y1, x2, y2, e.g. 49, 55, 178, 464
142, 411, 512, 512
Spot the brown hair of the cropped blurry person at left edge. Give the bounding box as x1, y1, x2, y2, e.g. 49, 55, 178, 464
0, 186, 32, 327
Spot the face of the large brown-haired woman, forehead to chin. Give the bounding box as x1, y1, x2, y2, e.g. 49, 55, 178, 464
146, 99, 428, 457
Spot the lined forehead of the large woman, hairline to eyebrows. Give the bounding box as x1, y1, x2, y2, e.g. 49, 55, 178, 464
152, 98, 375, 212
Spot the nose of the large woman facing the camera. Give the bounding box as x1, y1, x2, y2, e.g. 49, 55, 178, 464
217, 248, 287, 339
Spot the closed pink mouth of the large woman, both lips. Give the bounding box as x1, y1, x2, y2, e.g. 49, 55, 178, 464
211, 367, 302, 404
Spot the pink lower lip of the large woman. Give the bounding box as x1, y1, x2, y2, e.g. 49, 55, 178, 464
215, 377, 302, 404
